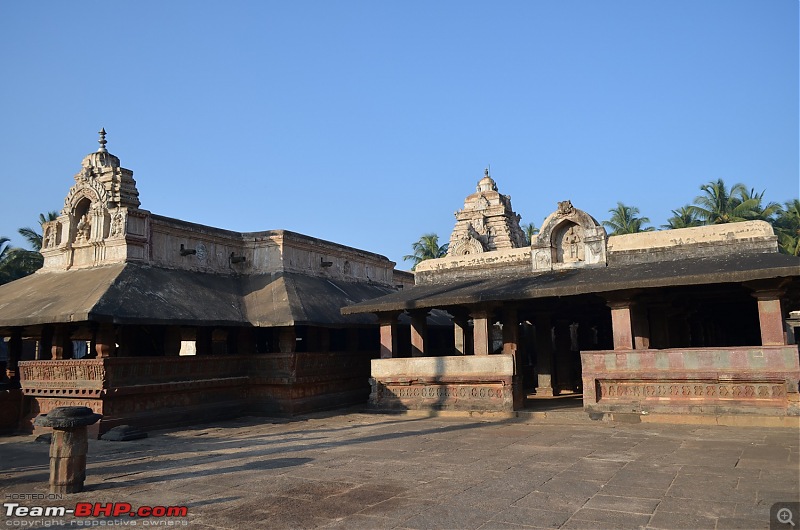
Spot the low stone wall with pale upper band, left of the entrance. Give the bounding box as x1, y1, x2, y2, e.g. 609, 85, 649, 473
369, 355, 522, 412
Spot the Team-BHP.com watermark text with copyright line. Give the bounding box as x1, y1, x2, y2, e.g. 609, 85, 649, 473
0, 493, 189, 528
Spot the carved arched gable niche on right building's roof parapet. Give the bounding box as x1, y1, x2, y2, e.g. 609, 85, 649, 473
531, 201, 608, 270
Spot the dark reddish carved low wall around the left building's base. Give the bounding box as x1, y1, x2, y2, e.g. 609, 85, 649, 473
20, 353, 376, 435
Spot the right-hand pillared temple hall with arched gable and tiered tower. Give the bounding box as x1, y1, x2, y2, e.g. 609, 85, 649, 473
342, 172, 800, 425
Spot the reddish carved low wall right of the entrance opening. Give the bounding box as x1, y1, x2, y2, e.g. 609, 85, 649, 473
581, 346, 800, 416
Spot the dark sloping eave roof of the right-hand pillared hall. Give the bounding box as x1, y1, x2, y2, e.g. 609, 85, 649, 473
342, 253, 800, 315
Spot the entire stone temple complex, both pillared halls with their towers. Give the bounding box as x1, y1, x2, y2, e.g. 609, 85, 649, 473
0, 131, 800, 435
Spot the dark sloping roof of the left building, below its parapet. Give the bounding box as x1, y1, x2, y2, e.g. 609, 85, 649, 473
0, 263, 404, 327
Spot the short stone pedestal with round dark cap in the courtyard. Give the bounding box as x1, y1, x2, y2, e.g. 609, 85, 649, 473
35, 407, 100, 493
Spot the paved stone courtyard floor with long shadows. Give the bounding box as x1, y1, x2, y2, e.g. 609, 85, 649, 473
0, 411, 800, 529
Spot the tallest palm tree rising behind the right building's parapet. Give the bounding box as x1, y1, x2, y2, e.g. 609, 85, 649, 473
690, 179, 763, 224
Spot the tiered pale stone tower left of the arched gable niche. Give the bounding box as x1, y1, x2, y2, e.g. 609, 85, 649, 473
447, 169, 526, 256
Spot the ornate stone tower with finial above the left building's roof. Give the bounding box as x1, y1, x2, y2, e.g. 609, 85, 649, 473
42, 129, 149, 269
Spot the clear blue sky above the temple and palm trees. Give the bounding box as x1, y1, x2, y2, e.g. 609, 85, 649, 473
0, 0, 798, 268
